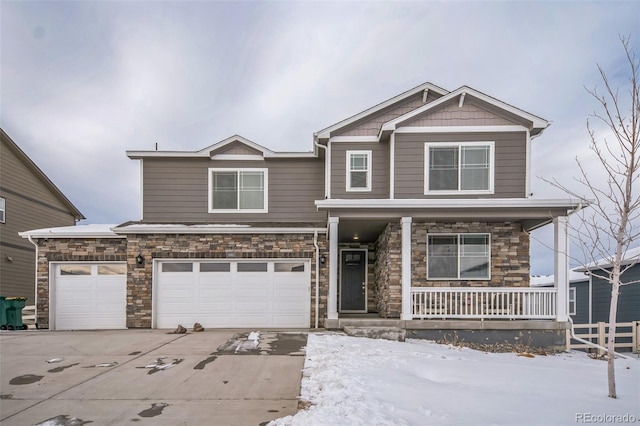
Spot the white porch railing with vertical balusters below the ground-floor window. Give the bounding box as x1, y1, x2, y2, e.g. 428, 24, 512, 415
411, 287, 557, 319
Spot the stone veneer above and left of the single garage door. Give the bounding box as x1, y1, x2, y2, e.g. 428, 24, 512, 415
36, 238, 127, 328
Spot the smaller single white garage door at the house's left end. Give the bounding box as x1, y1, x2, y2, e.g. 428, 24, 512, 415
52, 263, 127, 330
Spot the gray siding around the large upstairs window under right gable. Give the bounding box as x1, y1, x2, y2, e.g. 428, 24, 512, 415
394, 132, 527, 199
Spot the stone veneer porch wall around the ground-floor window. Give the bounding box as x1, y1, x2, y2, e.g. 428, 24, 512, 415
375, 222, 530, 318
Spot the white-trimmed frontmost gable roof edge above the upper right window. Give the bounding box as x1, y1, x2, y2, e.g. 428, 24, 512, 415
378, 86, 551, 138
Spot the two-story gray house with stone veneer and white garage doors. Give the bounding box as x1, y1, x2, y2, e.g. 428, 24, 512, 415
18, 83, 579, 350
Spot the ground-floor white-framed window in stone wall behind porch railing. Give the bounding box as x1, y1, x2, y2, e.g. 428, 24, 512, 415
427, 234, 491, 280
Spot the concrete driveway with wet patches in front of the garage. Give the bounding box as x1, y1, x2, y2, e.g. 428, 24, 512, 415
0, 330, 307, 426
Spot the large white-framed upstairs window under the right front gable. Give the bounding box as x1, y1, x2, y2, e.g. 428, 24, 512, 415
425, 142, 494, 194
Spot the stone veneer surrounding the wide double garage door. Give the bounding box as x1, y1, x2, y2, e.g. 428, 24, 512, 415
127, 234, 329, 328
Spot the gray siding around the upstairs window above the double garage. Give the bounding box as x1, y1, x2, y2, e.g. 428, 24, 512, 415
143, 158, 326, 223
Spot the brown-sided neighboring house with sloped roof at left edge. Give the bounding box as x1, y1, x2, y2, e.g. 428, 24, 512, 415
0, 129, 84, 304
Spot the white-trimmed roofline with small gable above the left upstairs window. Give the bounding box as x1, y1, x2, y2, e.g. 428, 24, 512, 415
127, 135, 315, 160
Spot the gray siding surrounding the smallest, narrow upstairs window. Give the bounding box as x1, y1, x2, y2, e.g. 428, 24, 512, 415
331, 142, 389, 199
